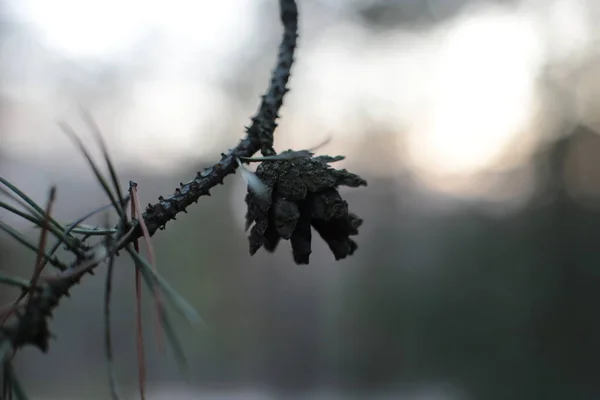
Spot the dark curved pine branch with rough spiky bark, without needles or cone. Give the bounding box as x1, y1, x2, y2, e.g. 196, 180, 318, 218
0, 0, 298, 360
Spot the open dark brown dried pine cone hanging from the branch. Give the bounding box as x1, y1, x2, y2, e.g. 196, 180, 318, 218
246, 150, 367, 264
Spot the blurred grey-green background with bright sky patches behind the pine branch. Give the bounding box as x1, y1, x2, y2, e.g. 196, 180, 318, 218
0, 0, 600, 400
